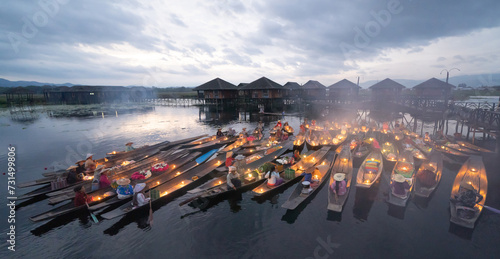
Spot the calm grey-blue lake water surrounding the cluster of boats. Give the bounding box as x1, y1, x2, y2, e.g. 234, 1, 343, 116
0, 104, 500, 258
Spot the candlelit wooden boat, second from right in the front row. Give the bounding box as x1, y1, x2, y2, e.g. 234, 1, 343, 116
415, 151, 443, 197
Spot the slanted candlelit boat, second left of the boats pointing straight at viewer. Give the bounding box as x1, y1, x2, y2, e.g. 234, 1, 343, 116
252, 147, 331, 196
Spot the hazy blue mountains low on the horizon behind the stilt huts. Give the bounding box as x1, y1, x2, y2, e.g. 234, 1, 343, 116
0, 74, 500, 88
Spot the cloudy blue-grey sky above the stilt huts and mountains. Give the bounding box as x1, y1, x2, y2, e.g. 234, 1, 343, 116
0, 0, 500, 86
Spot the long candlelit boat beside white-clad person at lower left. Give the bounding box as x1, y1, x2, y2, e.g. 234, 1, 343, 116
99, 154, 230, 219
